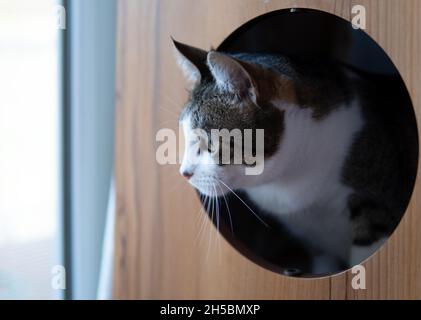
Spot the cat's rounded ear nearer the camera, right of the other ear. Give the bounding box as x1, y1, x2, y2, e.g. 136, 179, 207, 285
207, 51, 257, 102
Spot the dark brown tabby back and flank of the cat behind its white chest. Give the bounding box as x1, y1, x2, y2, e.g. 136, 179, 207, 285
233, 53, 418, 243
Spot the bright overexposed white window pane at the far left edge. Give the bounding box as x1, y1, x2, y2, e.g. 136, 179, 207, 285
0, 0, 61, 299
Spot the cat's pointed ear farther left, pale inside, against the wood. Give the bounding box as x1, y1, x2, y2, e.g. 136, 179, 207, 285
172, 39, 208, 86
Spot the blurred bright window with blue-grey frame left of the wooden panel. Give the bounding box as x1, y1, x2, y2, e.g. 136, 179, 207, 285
0, 0, 116, 299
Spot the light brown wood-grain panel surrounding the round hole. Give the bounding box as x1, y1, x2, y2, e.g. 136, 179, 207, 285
114, 0, 421, 299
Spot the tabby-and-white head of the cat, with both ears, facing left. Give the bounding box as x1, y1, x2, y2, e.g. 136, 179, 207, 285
174, 41, 283, 196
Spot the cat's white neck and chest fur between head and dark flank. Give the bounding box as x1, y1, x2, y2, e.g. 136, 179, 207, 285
245, 103, 363, 259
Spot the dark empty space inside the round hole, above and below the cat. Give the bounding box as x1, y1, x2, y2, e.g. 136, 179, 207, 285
197, 9, 418, 277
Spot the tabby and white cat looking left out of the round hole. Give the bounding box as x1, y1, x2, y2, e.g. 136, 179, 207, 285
174, 41, 418, 275
